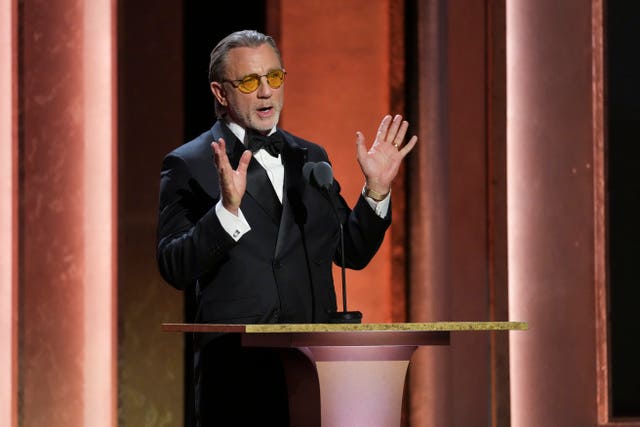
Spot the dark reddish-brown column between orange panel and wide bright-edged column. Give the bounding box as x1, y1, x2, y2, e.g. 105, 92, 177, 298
408, 0, 509, 426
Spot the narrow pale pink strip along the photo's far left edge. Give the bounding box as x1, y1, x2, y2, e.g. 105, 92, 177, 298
0, 0, 18, 427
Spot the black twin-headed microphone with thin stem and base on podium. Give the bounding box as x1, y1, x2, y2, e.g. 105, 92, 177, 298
302, 162, 362, 323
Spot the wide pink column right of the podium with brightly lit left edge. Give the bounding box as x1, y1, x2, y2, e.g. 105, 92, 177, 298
507, 0, 601, 427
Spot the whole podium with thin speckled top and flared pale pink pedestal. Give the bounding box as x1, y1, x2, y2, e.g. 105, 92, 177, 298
162, 322, 528, 427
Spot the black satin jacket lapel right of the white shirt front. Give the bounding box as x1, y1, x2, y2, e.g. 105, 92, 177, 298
275, 135, 307, 257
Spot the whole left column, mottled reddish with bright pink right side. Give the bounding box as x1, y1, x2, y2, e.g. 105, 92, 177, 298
18, 0, 117, 426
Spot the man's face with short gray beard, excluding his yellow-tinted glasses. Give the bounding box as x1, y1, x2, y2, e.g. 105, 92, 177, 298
211, 44, 284, 133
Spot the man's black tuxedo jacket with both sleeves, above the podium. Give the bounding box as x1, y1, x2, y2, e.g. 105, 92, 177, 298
157, 121, 391, 323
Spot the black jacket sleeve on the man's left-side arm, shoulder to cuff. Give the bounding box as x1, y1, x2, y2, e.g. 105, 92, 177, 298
156, 154, 236, 289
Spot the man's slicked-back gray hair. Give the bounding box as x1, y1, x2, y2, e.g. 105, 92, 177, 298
209, 30, 282, 118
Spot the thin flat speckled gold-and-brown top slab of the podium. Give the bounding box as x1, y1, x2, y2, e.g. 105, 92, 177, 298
162, 322, 529, 334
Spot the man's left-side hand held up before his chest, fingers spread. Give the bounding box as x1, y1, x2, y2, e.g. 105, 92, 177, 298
211, 138, 251, 215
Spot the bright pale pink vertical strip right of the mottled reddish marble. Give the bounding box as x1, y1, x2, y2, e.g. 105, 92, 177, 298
80, 0, 118, 427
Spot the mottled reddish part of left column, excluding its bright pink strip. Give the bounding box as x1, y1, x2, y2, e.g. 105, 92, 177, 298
20, 0, 85, 426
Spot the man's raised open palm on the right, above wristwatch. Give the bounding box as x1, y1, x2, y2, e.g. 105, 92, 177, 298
356, 115, 418, 195
